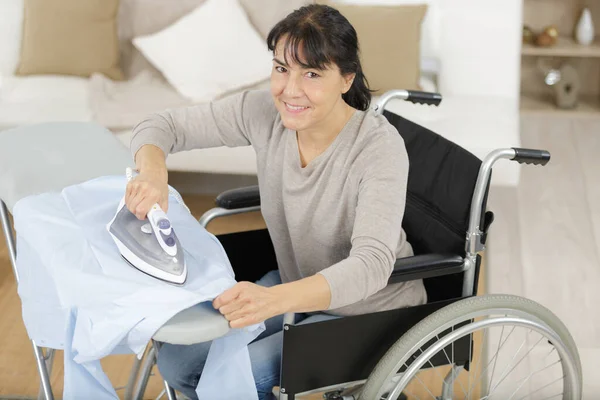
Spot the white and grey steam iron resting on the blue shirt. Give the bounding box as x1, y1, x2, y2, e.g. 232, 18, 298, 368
106, 168, 187, 285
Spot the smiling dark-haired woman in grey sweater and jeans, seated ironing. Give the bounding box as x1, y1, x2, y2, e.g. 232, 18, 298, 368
126, 5, 426, 399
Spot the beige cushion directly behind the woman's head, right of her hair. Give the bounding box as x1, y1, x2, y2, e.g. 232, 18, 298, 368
319, 0, 427, 95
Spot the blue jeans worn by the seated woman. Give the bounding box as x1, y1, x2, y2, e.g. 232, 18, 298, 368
157, 271, 338, 400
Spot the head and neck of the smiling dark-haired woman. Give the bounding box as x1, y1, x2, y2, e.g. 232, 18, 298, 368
267, 6, 378, 167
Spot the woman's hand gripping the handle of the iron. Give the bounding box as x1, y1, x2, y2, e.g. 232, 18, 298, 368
125, 172, 169, 220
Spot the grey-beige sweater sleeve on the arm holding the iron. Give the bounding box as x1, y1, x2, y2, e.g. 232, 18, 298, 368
130, 90, 277, 159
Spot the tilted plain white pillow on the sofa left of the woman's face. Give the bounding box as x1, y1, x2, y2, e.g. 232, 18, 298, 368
133, 0, 272, 102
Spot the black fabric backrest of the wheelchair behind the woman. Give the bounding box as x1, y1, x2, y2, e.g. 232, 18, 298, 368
383, 110, 487, 301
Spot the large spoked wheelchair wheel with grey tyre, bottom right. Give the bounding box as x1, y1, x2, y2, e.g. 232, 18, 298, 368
359, 295, 582, 400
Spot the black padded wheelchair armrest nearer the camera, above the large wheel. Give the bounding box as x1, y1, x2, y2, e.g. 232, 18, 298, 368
388, 254, 464, 283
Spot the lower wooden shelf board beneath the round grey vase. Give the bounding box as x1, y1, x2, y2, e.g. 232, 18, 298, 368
520, 93, 600, 118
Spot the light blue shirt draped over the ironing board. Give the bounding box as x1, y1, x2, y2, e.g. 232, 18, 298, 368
13, 176, 264, 400
